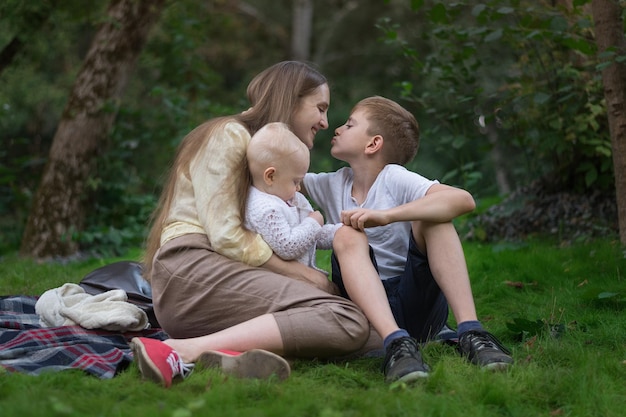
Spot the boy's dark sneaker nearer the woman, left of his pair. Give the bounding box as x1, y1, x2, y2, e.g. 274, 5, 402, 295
383, 337, 430, 382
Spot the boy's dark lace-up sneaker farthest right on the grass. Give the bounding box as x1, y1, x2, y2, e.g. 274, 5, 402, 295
459, 330, 513, 370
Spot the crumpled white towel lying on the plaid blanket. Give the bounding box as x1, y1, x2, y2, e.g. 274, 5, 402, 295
35, 283, 150, 332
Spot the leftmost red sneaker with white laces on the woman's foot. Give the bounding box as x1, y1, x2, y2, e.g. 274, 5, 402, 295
130, 337, 193, 388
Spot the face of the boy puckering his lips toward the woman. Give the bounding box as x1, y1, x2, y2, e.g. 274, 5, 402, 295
330, 109, 371, 163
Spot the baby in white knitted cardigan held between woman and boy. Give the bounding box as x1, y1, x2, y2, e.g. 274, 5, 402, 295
244, 123, 341, 275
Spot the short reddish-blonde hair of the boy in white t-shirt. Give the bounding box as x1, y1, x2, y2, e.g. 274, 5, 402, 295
352, 96, 419, 165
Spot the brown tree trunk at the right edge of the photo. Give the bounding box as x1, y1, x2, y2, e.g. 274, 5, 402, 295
591, 0, 626, 246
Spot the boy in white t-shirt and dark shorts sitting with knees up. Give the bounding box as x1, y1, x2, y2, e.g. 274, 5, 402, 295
303, 97, 513, 382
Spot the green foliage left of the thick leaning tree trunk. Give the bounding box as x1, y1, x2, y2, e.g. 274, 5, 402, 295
0, 0, 106, 253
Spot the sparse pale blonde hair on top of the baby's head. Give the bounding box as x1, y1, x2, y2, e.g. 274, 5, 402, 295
246, 122, 310, 174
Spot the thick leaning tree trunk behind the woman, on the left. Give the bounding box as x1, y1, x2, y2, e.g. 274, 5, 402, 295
20, 0, 165, 258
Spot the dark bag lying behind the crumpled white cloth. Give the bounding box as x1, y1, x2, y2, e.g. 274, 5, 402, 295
78, 261, 161, 328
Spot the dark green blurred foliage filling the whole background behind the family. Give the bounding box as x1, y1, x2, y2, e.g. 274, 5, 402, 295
0, 0, 624, 254
